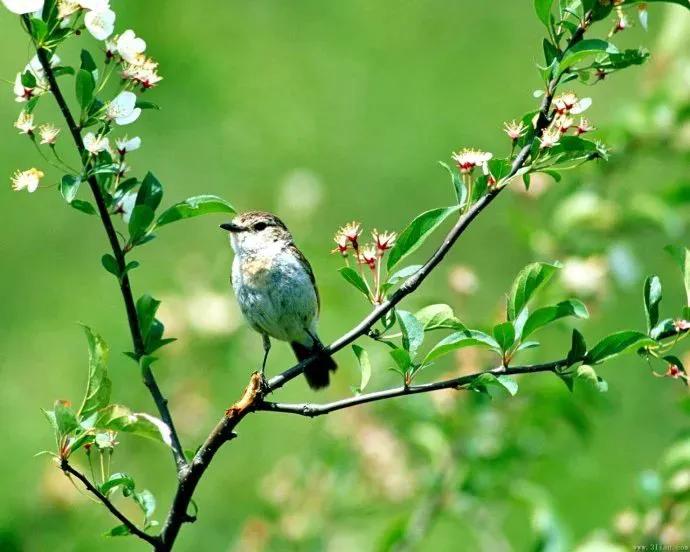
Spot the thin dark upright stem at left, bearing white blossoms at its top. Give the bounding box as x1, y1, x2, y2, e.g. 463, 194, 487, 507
30, 27, 187, 471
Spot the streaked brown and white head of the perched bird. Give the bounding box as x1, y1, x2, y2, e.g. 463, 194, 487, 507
220, 211, 292, 255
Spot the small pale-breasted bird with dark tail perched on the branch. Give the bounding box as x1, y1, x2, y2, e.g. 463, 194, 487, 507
220, 211, 337, 389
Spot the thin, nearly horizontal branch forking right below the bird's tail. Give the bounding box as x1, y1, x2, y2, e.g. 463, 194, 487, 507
256, 359, 567, 418
